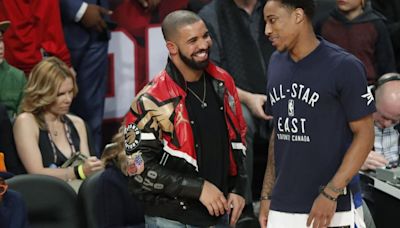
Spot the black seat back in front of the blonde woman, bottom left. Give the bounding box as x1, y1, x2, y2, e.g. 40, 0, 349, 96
7, 174, 83, 228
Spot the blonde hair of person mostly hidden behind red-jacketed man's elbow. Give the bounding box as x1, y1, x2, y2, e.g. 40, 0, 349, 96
101, 124, 127, 175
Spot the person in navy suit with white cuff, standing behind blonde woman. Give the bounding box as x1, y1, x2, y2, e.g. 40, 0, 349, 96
60, 0, 112, 155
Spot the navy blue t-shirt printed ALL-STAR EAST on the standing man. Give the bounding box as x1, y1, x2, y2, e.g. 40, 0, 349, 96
266, 39, 375, 213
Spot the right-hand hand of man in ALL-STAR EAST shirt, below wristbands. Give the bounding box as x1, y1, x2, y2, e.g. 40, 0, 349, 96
307, 194, 337, 228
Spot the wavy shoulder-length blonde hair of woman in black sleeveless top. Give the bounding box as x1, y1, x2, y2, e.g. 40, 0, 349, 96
21, 57, 78, 129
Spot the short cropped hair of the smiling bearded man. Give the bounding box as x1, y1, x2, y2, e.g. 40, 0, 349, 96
161, 10, 202, 40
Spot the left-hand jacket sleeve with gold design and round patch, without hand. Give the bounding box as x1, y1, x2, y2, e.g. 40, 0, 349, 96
125, 94, 204, 200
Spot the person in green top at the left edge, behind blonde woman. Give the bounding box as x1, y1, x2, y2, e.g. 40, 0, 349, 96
0, 20, 26, 119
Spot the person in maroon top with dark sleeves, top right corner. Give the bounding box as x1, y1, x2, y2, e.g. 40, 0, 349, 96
316, 0, 396, 85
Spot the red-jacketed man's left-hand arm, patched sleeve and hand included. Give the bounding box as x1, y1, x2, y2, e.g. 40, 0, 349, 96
125, 92, 228, 219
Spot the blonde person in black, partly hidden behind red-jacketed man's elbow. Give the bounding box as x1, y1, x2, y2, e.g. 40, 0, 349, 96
96, 128, 144, 227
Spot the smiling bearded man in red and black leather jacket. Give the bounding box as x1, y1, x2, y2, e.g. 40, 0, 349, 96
125, 10, 247, 227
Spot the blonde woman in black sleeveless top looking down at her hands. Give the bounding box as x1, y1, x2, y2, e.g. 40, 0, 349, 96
13, 57, 103, 180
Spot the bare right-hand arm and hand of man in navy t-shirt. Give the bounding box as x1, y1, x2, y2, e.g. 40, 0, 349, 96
307, 115, 374, 227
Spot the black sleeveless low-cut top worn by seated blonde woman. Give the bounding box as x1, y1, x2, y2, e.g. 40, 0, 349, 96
39, 115, 81, 168
